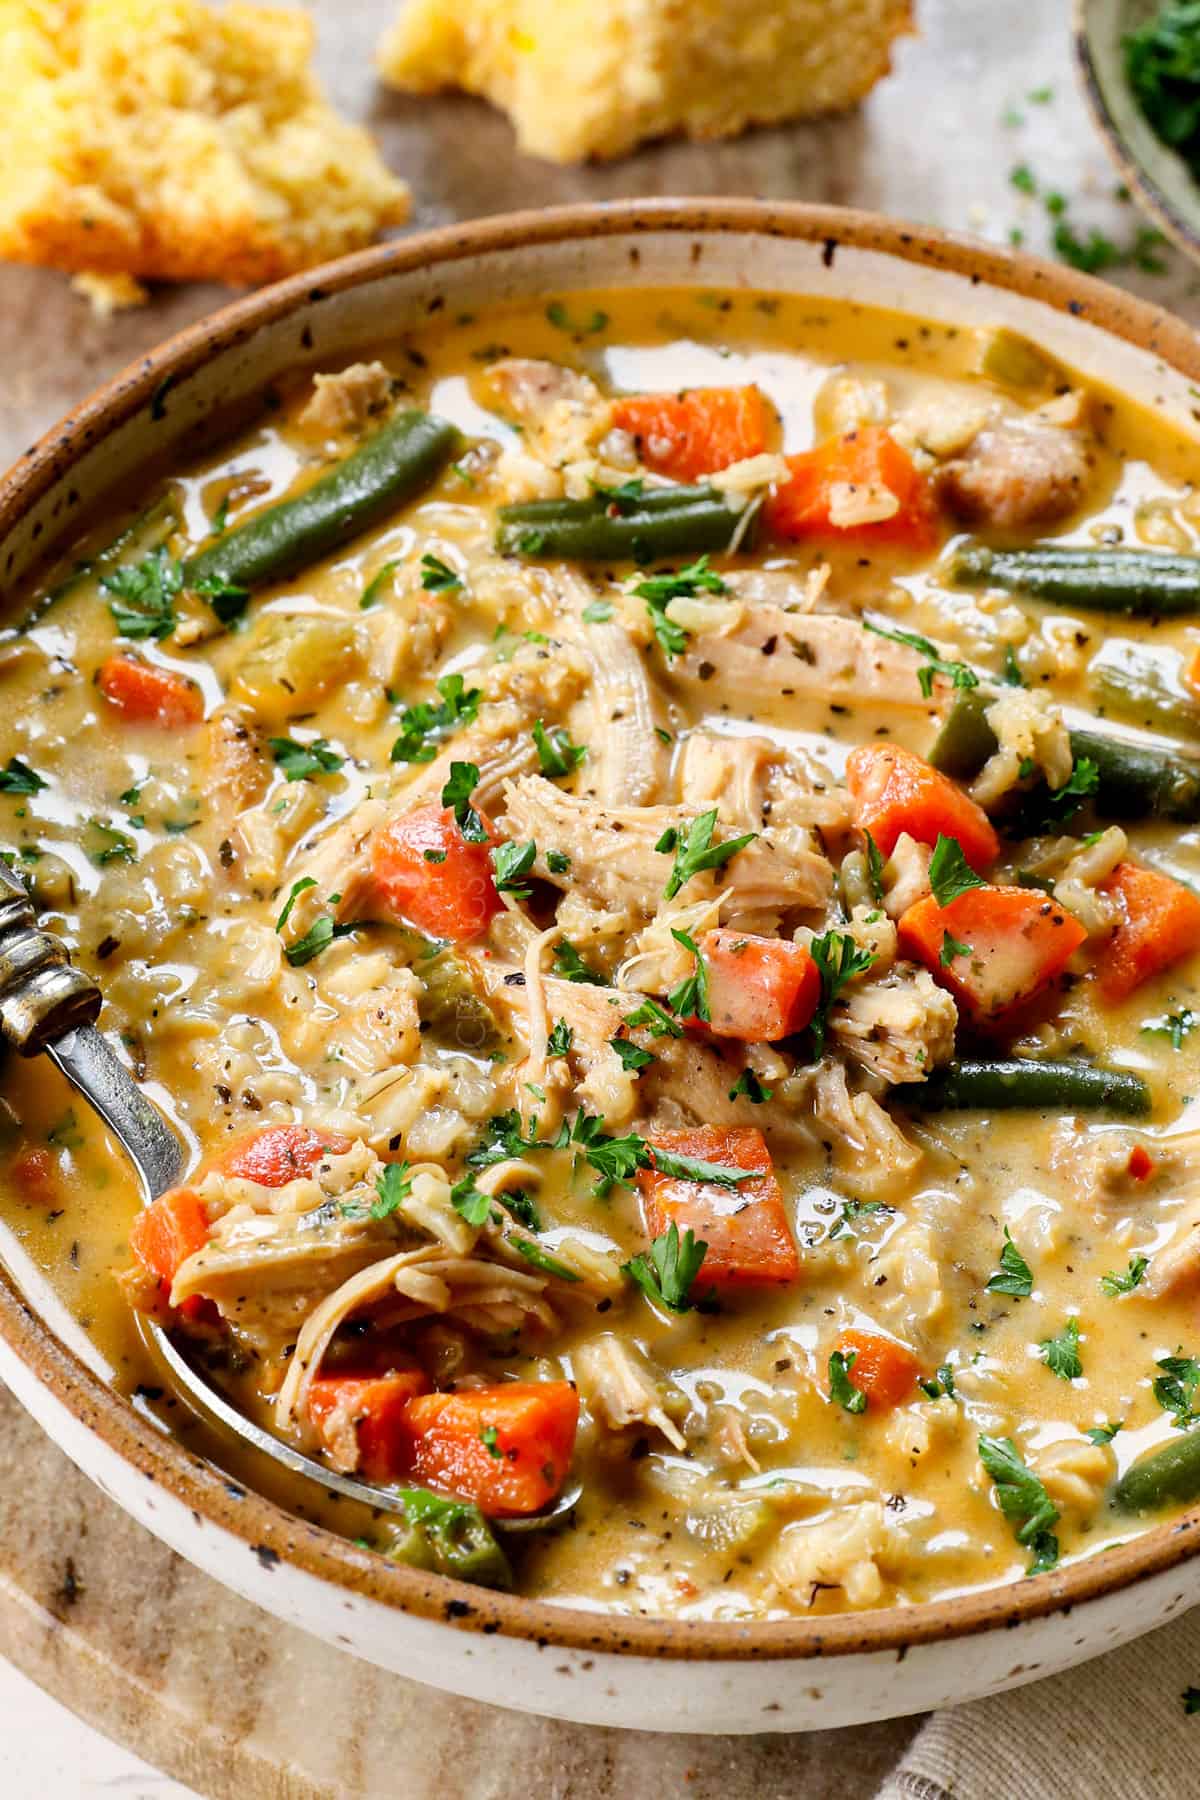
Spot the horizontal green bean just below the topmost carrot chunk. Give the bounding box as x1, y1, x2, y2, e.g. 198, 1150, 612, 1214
497, 488, 754, 563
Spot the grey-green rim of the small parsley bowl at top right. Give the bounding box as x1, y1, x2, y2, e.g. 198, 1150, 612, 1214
1072, 0, 1200, 263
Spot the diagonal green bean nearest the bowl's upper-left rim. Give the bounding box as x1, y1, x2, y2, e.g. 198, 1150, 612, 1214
184, 410, 459, 589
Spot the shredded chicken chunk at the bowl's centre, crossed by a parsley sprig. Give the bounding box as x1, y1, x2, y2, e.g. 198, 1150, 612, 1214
498, 776, 833, 918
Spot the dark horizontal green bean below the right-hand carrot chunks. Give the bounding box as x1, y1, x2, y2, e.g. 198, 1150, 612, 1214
892, 1057, 1150, 1118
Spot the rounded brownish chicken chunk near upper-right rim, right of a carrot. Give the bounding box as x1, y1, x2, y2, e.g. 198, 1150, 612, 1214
937, 419, 1096, 531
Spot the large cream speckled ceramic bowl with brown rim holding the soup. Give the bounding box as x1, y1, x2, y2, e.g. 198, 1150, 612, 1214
0, 202, 1200, 1732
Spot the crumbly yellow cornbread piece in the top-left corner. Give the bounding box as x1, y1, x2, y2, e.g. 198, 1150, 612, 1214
0, 0, 408, 283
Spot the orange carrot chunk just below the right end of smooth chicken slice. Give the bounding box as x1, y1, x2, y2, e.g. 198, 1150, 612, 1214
846, 743, 1000, 875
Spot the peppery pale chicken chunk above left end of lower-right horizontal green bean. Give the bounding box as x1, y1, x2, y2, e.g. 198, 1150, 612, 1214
828, 963, 959, 1084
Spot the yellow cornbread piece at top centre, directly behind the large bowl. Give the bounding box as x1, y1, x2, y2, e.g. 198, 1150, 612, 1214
380, 0, 912, 162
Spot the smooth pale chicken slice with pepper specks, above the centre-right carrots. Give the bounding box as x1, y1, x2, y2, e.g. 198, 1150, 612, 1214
671, 607, 945, 711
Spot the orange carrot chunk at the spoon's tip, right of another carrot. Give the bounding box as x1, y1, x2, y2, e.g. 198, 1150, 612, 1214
395, 1381, 579, 1519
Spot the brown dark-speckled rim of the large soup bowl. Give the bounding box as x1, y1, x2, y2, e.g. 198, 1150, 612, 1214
0, 200, 1200, 1663
